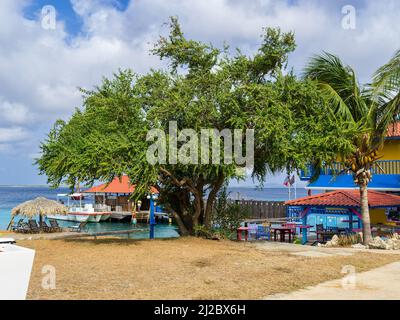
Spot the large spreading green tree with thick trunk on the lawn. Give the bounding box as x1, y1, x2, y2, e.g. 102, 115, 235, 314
37, 18, 352, 234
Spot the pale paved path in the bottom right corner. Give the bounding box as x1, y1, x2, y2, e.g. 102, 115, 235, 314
266, 262, 400, 300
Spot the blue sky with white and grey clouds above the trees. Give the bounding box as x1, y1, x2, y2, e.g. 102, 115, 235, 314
0, 0, 400, 185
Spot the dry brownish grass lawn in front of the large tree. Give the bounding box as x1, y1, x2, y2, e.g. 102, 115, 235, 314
19, 238, 399, 299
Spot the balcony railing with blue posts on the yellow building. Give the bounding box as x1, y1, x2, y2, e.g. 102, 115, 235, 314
300, 160, 400, 180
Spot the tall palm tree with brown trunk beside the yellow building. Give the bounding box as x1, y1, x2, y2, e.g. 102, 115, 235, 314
304, 51, 400, 244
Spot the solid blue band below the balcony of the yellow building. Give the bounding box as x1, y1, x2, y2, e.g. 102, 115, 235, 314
306, 174, 400, 191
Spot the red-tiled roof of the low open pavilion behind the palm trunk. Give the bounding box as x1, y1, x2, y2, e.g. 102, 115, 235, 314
285, 190, 400, 208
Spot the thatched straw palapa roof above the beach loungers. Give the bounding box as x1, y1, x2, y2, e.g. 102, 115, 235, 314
11, 197, 68, 218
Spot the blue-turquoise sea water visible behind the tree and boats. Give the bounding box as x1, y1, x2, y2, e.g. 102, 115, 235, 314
0, 186, 307, 238
